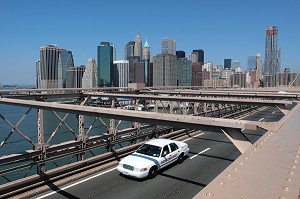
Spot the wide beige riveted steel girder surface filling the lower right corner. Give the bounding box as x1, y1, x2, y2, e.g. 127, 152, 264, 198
194, 104, 300, 199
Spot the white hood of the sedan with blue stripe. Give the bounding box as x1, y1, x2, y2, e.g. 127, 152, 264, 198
120, 153, 160, 168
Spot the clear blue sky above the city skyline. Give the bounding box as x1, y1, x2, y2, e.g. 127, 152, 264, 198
0, 0, 300, 84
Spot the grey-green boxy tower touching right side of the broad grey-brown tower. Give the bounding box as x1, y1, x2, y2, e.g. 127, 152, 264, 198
176, 58, 192, 86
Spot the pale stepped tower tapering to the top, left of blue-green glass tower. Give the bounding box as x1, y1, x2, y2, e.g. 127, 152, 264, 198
82, 59, 98, 88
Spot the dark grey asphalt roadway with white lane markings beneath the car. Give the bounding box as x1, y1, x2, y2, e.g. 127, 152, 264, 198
34, 107, 283, 199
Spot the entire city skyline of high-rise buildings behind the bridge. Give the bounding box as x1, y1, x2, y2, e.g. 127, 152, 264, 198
36, 26, 300, 89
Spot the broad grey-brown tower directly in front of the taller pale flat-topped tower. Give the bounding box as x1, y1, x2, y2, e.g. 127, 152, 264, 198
153, 54, 177, 86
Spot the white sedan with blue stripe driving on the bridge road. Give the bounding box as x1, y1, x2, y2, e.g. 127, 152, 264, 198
117, 139, 189, 178
